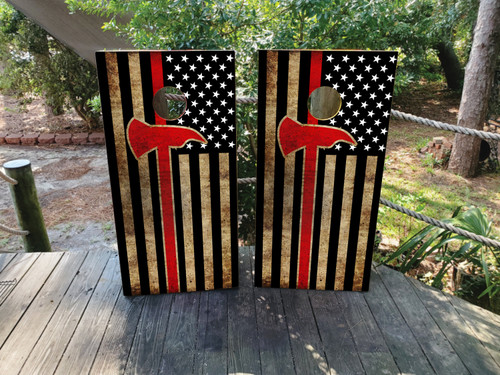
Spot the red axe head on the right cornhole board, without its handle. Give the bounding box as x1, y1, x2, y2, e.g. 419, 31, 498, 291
278, 116, 357, 156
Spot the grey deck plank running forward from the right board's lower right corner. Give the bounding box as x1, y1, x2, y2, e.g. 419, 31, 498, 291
364, 272, 434, 375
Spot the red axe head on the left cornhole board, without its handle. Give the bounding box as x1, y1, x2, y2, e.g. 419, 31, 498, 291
127, 118, 207, 159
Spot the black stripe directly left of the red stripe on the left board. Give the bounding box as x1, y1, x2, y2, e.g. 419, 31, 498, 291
139, 53, 167, 293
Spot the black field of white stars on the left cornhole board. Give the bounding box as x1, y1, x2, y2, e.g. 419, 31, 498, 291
162, 51, 236, 153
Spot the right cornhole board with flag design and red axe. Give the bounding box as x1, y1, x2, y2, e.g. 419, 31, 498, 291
255, 50, 397, 291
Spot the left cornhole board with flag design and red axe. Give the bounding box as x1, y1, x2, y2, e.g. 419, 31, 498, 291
96, 51, 238, 295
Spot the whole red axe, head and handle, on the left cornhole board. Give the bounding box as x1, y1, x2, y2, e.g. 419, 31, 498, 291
127, 118, 207, 293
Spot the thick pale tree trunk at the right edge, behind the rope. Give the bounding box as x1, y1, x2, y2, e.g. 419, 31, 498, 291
449, 0, 500, 177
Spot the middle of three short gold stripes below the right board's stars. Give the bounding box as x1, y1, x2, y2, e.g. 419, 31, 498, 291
335, 155, 357, 290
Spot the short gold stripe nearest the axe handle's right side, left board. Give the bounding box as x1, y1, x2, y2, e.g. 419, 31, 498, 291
179, 154, 196, 292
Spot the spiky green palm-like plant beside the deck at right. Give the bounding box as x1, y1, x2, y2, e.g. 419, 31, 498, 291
383, 207, 500, 299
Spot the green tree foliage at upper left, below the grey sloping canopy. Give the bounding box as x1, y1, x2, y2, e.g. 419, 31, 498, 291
0, 2, 100, 128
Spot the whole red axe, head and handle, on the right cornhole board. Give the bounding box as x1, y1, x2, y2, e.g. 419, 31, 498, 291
278, 116, 357, 289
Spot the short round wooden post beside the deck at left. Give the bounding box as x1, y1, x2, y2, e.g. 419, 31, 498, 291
3, 159, 51, 252
